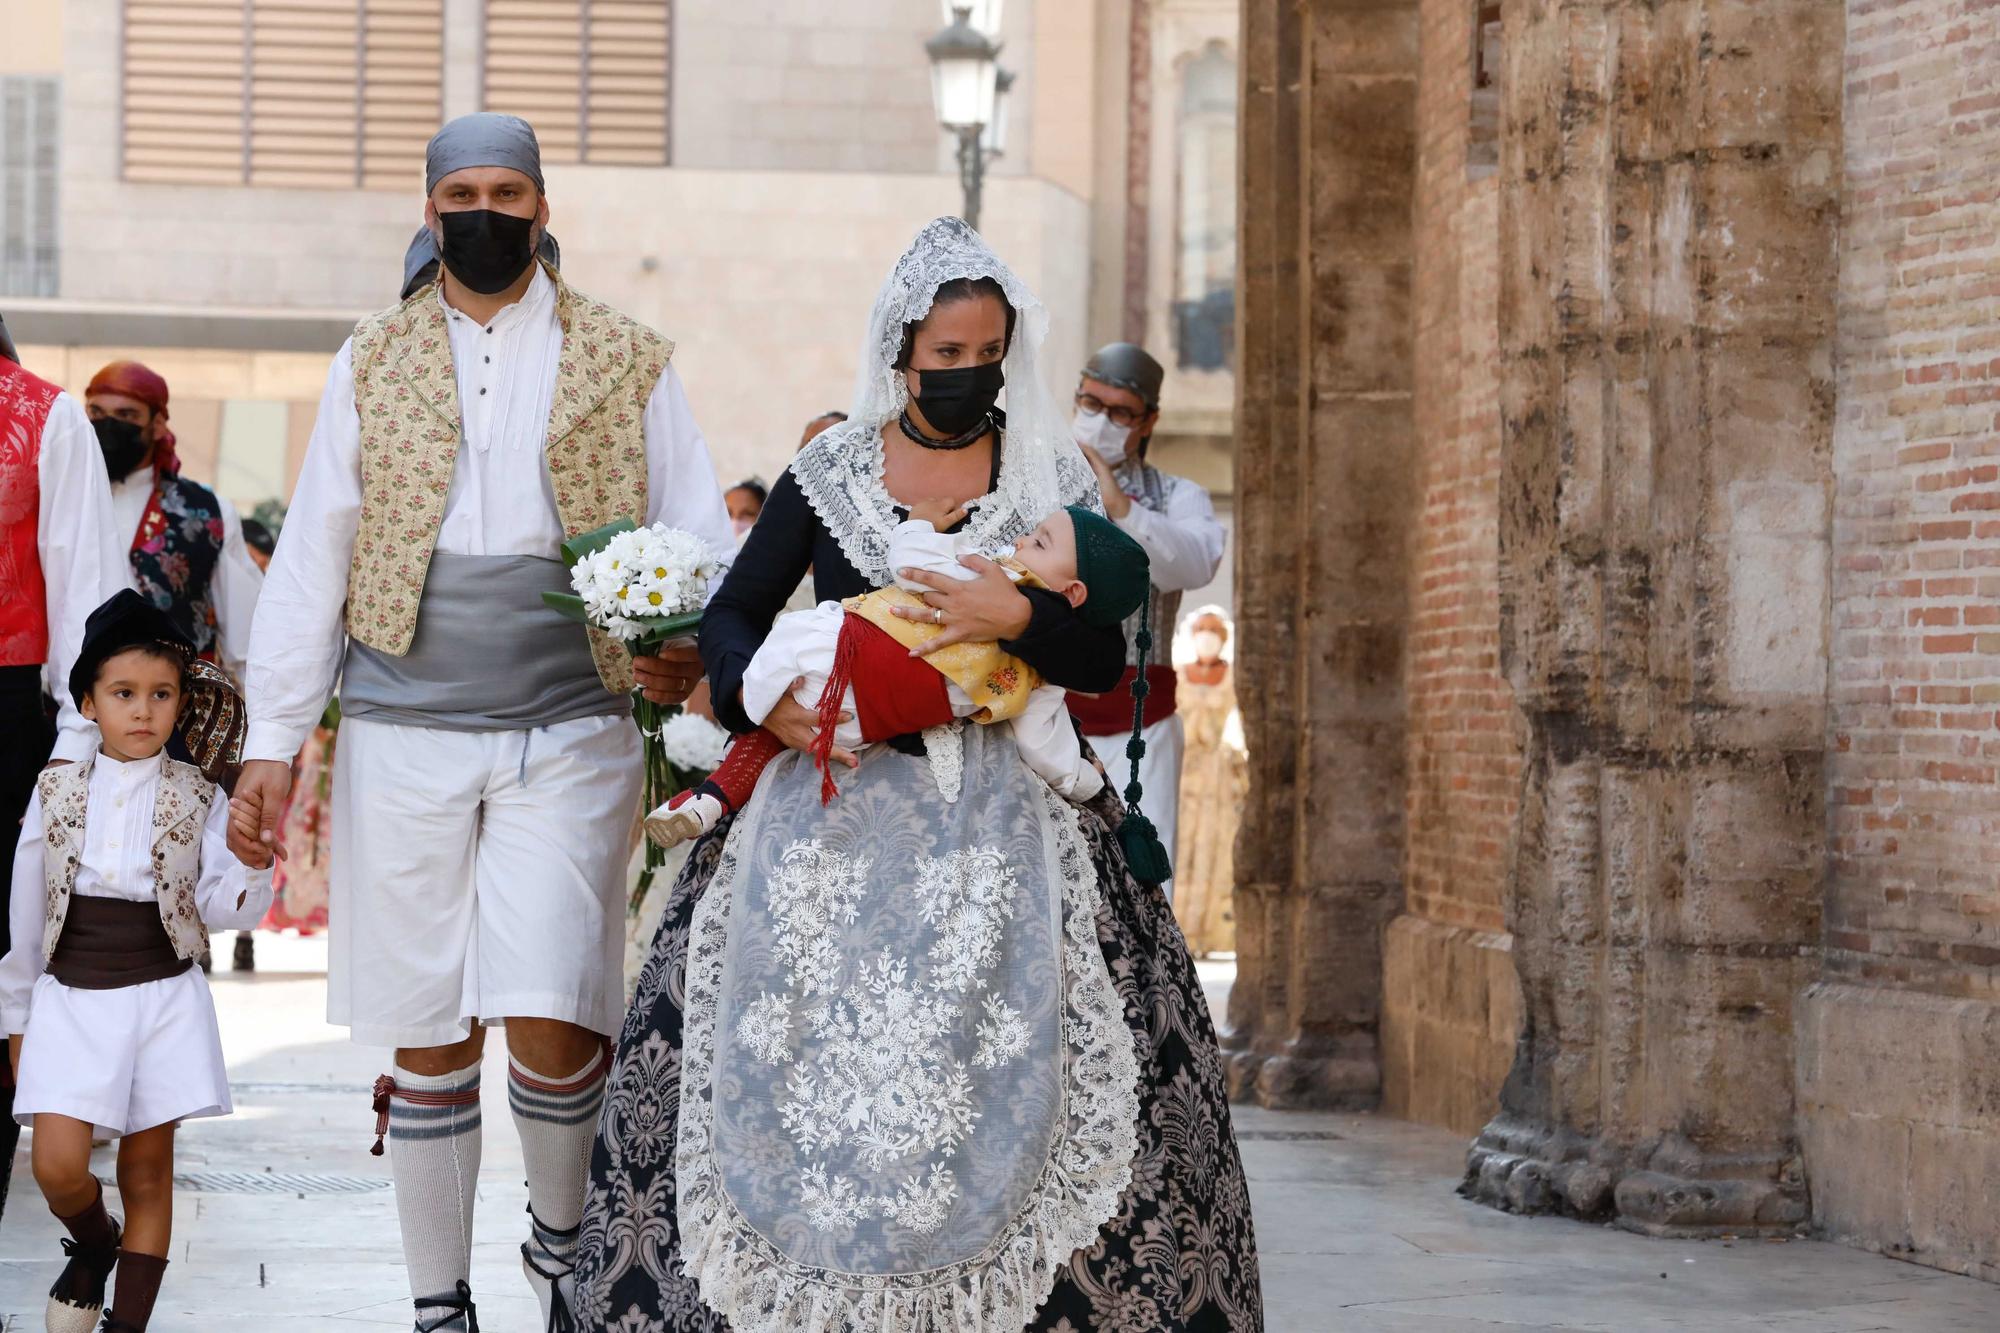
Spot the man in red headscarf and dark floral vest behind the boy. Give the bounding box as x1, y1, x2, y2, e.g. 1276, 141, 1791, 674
84, 360, 264, 681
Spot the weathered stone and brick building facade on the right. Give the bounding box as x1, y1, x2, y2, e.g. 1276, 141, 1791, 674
1230, 0, 2000, 1279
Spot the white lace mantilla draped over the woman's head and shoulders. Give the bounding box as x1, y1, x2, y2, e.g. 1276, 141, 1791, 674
792, 218, 1104, 588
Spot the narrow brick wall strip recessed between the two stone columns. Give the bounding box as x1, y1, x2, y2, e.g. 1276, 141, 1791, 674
1382, 0, 1520, 1133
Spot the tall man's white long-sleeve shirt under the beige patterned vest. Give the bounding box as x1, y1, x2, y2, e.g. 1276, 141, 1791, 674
244, 270, 736, 763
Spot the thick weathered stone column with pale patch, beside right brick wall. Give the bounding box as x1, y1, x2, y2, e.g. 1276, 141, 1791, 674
1466, 0, 1842, 1233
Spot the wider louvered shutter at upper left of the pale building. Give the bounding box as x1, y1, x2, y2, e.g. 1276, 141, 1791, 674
124, 0, 444, 188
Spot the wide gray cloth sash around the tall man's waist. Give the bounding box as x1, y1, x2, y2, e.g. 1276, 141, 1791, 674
340, 554, 632, 731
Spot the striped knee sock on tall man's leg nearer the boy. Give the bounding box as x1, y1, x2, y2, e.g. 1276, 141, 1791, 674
388, 1065, 480, 1327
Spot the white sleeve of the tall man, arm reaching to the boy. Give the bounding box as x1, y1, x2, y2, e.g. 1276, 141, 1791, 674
244, 342, 362, 763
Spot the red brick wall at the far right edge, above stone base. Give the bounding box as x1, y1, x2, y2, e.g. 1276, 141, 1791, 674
1826, 0, 2000, 999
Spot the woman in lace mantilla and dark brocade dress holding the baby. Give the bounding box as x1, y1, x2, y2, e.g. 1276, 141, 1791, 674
576, 218, 1262, 1333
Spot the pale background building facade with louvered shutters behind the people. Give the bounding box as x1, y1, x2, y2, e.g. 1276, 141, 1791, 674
0, 0, 1236, 596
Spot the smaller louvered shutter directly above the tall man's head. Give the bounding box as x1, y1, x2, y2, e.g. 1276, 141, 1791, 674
486, 0, 672, 164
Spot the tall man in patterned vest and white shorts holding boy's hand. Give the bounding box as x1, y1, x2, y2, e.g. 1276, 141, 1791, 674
232, 114, 734, 1333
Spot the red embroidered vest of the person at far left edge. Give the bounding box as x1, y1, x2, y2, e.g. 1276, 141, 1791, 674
0, 356, 62, 667
